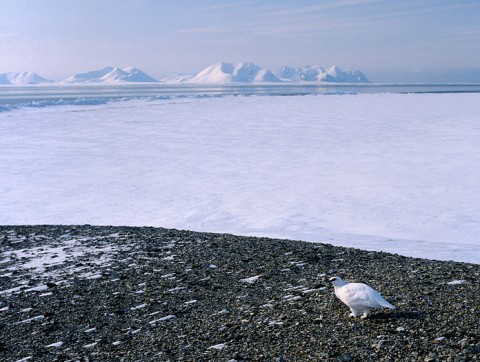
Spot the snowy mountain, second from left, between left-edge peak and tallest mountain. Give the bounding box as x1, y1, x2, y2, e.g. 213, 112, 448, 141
63, 67, 158, 83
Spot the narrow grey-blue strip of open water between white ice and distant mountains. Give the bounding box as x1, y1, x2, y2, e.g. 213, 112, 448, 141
0, 83, 480, 112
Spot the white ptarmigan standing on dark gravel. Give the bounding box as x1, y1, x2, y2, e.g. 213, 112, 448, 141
329, 277, 395, 318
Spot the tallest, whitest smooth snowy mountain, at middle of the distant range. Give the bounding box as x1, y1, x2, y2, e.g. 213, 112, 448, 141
189, 63, 280, 83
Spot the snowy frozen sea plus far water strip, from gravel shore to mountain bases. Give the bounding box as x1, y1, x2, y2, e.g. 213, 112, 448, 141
0, 85, 480, 263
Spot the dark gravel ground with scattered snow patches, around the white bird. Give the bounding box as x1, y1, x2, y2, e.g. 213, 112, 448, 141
0, 225, 480, 361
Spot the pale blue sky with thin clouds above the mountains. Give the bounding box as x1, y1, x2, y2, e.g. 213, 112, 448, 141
0, 0, 480, 82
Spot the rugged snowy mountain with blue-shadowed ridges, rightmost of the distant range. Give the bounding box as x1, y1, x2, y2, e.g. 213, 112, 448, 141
273, 65, 369, 83
